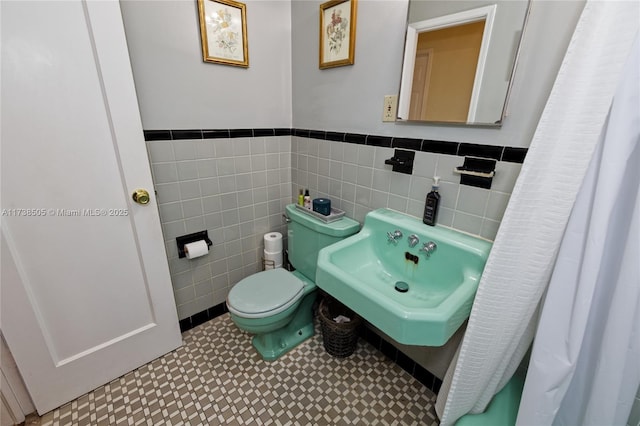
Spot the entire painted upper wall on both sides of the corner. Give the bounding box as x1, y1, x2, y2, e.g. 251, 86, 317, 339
122, 0, 584, 147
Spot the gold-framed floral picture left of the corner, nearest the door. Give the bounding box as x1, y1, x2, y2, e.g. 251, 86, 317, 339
198, 0, 249, 68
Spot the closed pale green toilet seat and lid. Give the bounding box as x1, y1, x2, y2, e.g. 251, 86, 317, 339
227, 268, 304, 318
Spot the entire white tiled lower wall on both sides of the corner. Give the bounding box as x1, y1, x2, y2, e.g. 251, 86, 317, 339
147, 136, 520, 319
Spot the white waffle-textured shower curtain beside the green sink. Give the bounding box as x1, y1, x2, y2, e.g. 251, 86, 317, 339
436, 0, 640, 426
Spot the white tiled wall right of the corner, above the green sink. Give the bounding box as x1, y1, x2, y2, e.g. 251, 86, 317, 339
291, 136, 521, 240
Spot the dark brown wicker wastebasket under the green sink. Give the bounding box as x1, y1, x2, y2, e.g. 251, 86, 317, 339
318, 297, 362, 358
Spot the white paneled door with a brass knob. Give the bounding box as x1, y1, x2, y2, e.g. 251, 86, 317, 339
0, 0, 181, 414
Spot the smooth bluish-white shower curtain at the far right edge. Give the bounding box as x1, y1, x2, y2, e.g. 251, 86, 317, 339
517, 35, 640, 425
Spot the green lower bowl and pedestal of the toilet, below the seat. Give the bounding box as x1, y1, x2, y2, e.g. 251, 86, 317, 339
251, 291, 317, 361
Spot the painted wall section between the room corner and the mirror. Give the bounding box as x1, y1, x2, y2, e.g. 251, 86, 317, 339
291, 0, 407, 135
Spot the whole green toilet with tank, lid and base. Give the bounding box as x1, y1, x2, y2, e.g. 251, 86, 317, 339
227, 204, 360, 361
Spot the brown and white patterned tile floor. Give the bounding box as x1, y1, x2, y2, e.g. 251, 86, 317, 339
25, 314, 438, 426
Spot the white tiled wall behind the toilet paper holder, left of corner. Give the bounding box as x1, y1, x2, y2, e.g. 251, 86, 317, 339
147, 136, 291, 319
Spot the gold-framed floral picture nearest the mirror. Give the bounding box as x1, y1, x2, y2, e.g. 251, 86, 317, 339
320, 0, 357, 68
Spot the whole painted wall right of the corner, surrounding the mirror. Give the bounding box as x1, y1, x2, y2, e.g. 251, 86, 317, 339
292, 0, 584, 147
